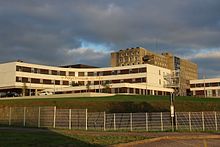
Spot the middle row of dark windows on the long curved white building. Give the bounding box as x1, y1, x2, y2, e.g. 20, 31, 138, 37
16, 77, 146, 86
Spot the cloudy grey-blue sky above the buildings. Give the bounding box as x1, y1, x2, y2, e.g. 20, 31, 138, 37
0, 0, 220, 78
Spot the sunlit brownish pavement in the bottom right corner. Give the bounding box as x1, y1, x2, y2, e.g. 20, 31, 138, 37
114, 133, 220, 147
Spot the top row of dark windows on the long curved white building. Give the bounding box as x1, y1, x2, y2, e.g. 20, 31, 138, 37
16, 66, 147, 77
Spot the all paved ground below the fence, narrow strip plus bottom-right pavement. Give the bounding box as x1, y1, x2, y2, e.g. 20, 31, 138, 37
0, 127, 220, 147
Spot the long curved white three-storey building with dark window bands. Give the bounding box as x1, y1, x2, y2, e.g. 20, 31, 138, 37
0, 61, 173, 96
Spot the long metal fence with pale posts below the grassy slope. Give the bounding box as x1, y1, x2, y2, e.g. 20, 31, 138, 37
0, 107, 220, 131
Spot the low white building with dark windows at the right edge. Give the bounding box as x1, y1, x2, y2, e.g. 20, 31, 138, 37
190, 78, 220, 98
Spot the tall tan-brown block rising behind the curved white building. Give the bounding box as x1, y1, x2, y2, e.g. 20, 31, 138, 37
111, 47, 198, 95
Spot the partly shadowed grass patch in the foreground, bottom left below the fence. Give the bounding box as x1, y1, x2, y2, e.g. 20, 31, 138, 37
0, 129, 147, 147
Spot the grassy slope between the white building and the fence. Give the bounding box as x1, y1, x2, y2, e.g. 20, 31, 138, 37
0, 95, 220, 112
